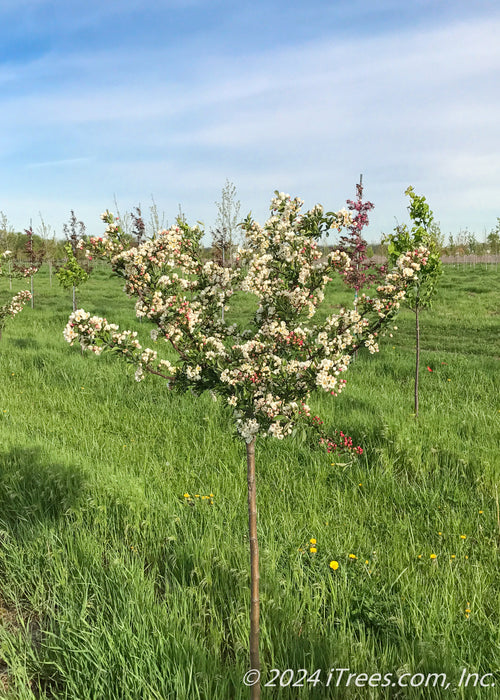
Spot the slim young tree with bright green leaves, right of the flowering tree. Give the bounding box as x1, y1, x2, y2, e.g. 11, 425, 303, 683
385, 186, 442, 416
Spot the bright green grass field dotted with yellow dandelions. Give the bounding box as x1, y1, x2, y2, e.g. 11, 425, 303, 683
0, 266, 500, 700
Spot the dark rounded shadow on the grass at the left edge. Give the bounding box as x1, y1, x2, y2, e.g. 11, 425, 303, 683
0, 447, 84, 532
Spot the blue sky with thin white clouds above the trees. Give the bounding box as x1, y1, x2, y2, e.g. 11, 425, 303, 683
0, 0, 500, 240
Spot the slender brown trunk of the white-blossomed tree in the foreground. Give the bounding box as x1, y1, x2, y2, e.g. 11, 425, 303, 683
247, 438, 260, 700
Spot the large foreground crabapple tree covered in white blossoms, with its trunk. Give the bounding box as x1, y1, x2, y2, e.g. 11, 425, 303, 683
64, 192, 425, 698
